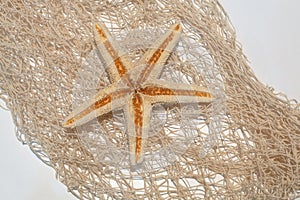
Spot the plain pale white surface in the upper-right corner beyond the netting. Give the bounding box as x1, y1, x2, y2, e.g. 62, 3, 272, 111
220, 0, 300, 101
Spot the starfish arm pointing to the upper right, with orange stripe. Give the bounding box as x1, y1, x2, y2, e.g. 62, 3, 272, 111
136, 23, 182, 84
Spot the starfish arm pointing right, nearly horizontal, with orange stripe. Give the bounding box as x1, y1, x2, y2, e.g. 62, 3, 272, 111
139, 80, 213, 103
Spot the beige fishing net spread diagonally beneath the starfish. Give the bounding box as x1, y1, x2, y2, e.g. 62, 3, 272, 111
0, 0, 300, 199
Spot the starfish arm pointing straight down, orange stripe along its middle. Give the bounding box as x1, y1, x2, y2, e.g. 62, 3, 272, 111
125, 93, 151, 165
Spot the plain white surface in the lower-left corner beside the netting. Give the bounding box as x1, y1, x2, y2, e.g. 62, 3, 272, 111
0, 107, 76, 200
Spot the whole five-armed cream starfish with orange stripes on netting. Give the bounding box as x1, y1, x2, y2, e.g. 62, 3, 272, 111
63, 23, 213, 165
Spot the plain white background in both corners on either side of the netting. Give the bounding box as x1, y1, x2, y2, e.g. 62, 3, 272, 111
0, 0, 300, 200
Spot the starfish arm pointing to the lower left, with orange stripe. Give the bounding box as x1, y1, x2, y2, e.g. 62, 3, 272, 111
62, 85, 129, 128
